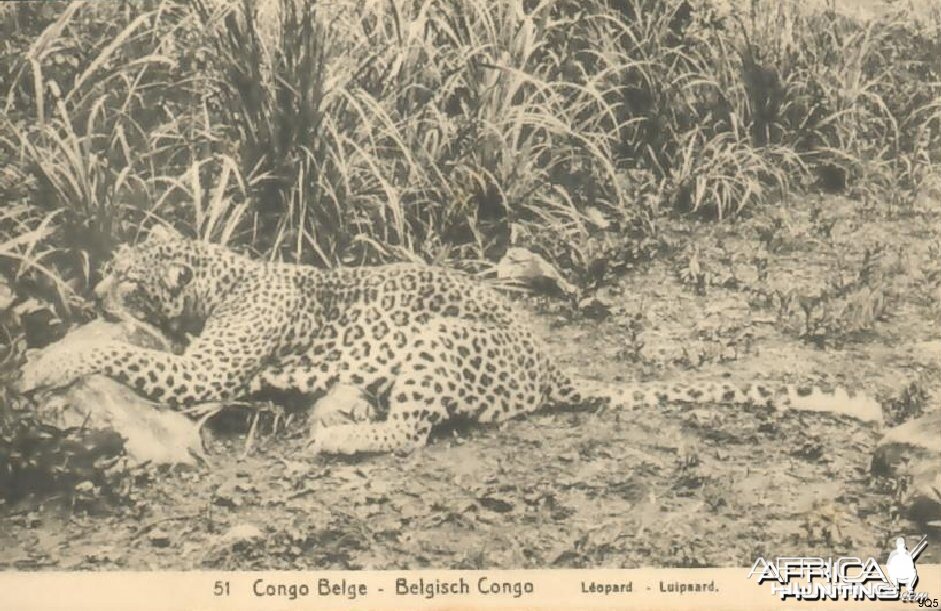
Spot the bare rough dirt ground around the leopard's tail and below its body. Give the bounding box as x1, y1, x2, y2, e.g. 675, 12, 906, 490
0, 198, 941, 569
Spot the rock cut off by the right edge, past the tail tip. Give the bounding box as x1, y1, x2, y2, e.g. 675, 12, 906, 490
871, 409, 941, 524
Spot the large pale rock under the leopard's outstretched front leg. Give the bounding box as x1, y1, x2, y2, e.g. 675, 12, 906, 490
19, 321, 203, 466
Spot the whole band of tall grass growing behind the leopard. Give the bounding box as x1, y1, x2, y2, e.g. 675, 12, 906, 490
0, 0, 941, 322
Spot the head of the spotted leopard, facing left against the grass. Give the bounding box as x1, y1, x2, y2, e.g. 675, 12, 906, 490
95, 226, 200, 326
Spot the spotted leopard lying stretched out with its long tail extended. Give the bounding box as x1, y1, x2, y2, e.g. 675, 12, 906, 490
19, 225, 880, 455
